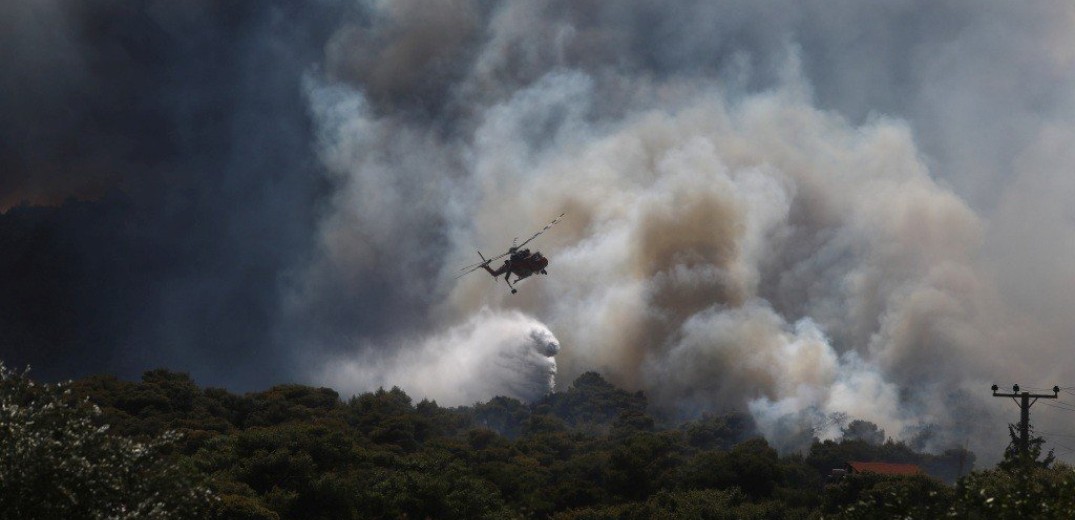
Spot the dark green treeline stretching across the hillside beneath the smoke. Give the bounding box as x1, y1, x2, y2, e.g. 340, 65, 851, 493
0, 365, 1075, 519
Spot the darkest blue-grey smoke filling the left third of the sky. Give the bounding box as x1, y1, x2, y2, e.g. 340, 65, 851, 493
0, 0, 352, 388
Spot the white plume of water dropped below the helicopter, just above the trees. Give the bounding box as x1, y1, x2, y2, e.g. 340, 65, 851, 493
323, 309, 560, 406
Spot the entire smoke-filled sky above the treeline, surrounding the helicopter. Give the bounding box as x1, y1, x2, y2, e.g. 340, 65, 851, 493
0, 0, 1075, 461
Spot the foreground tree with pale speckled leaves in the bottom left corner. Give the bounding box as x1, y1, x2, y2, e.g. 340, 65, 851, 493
0, 363, 215, 519
